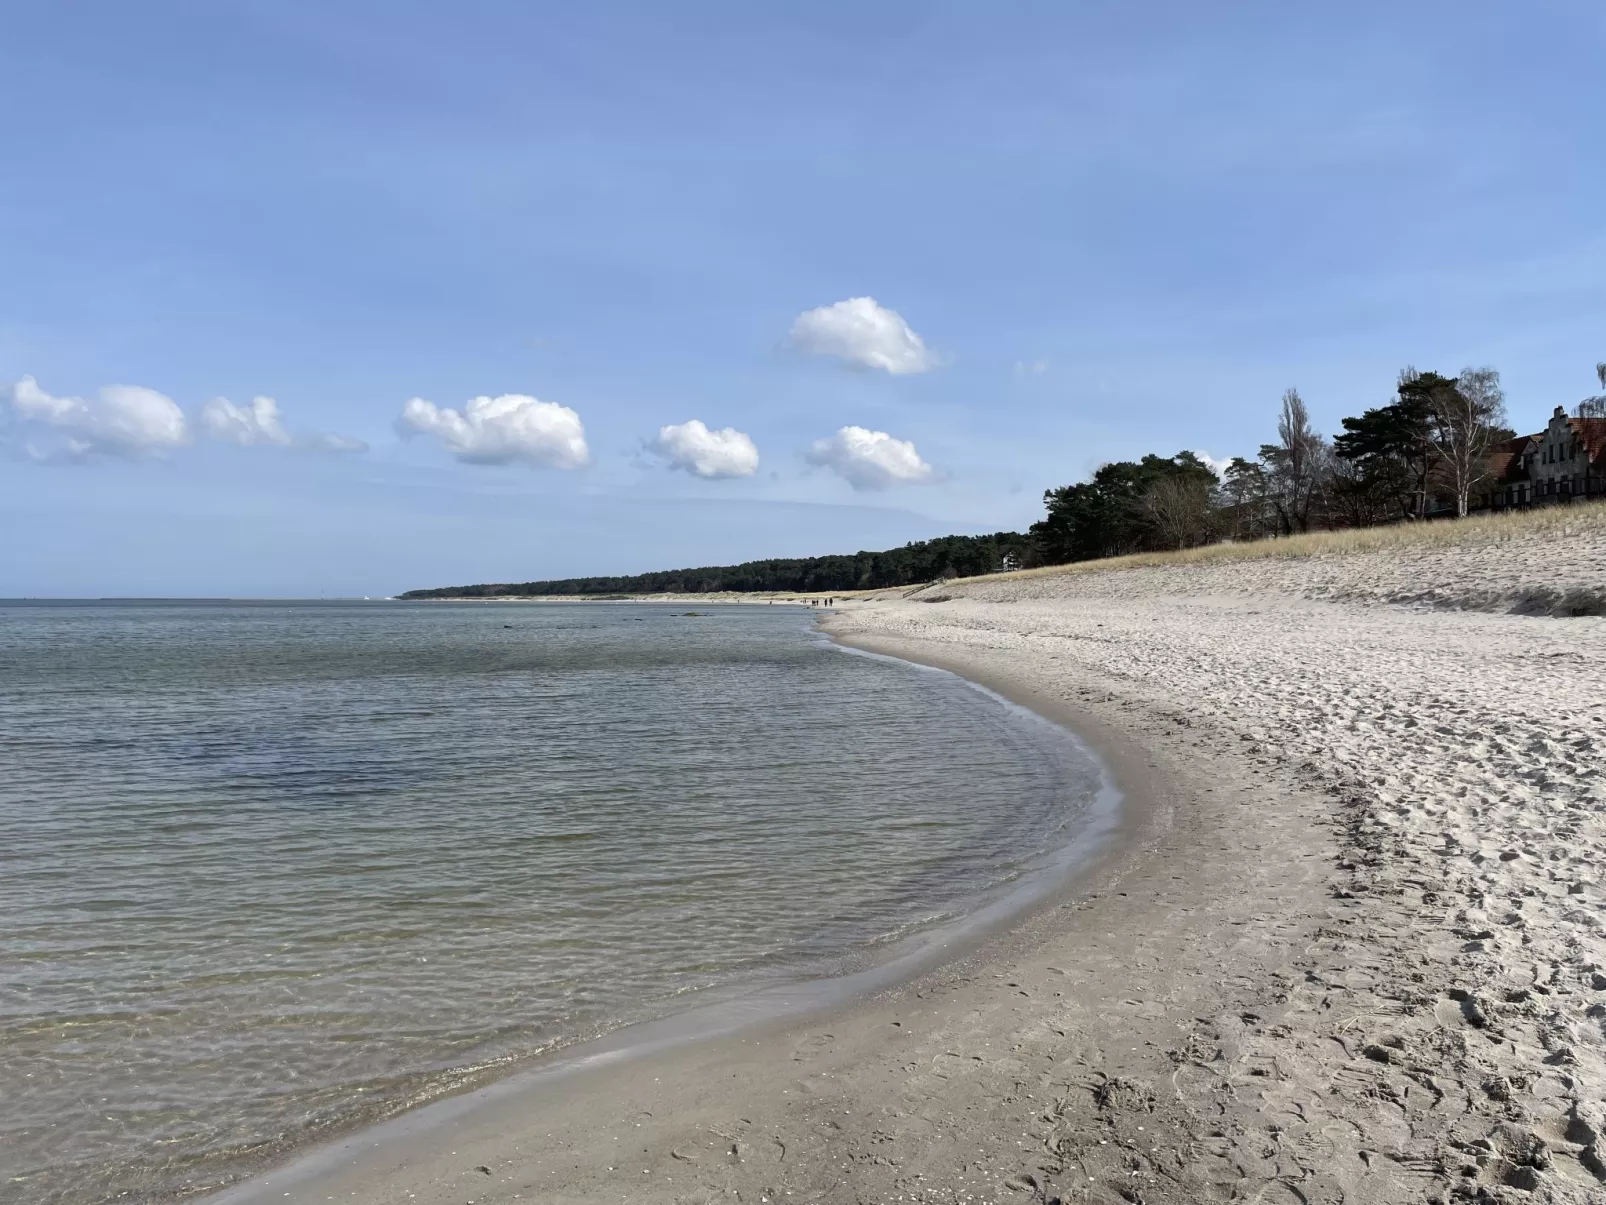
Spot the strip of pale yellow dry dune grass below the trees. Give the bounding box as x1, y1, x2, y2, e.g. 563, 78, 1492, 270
944, 503, 1606, 585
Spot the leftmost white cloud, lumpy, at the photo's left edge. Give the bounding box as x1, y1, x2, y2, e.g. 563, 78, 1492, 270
10, 376, 190, 460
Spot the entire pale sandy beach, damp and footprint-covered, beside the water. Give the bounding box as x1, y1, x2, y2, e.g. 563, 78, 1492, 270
213, 526, 1606, 1205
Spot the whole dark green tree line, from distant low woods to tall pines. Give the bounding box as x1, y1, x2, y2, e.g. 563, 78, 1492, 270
402, 365, 1606, 599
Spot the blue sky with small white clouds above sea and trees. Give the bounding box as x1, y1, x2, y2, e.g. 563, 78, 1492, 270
0, 0, 1606, 596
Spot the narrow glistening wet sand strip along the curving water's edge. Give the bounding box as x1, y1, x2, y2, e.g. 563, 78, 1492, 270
203, 626, 1147, 1205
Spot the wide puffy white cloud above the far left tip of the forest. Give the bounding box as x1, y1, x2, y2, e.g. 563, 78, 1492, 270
397, 394, 591, 469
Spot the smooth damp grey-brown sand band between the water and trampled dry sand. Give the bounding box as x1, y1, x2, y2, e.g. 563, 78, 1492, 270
187, 607, 1355, 1205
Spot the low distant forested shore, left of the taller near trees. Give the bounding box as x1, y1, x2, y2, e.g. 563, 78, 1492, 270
398, 532, 1031, 598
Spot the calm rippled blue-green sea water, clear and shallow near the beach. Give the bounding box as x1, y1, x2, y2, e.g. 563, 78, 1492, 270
0, 603, 1097, 1202
